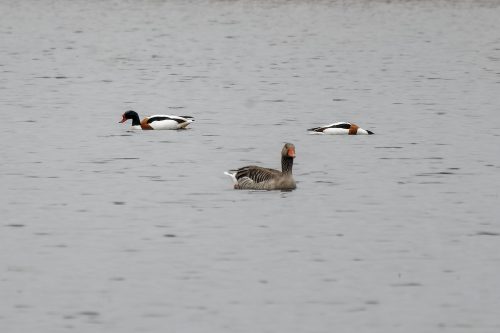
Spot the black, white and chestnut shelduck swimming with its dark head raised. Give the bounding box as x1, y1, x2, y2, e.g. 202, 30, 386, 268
120, 110, 194, 130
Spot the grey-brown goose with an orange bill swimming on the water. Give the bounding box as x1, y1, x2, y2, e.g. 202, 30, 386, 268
224, 143, 296, 190
